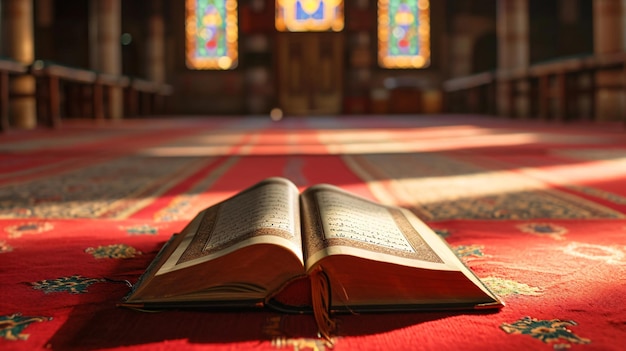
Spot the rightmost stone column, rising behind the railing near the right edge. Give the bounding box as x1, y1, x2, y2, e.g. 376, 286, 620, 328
593, 0, 626, 120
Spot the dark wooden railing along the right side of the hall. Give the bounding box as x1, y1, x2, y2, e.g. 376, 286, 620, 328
443, 53, 626, 120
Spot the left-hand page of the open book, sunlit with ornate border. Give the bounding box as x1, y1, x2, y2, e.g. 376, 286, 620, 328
157, 178, 302, 275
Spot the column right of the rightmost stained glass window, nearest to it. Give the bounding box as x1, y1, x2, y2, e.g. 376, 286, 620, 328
496, 0, 530, 117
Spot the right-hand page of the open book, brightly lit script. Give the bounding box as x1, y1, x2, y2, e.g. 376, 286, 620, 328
303, 185, 459, 270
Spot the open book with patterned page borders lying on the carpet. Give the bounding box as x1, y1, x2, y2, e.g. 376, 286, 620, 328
121, 177, 503, 324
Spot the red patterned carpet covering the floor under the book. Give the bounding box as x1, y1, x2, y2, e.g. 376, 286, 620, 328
0, 116, 626, 350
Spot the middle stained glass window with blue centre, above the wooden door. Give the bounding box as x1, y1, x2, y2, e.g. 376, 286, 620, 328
275, 0, 344, 32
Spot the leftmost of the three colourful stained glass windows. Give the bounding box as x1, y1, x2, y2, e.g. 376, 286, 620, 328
185, 0, 239, 70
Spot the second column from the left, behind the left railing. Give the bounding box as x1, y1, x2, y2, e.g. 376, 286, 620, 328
89, 0, 124, 119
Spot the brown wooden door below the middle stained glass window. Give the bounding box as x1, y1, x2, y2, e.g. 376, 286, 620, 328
277, 33, 344, 115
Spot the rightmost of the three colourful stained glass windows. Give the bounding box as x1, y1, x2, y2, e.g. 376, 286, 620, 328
378, 0, 430, 68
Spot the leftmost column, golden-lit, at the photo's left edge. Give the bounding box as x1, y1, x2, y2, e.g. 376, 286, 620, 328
2, 0, 37, 129
